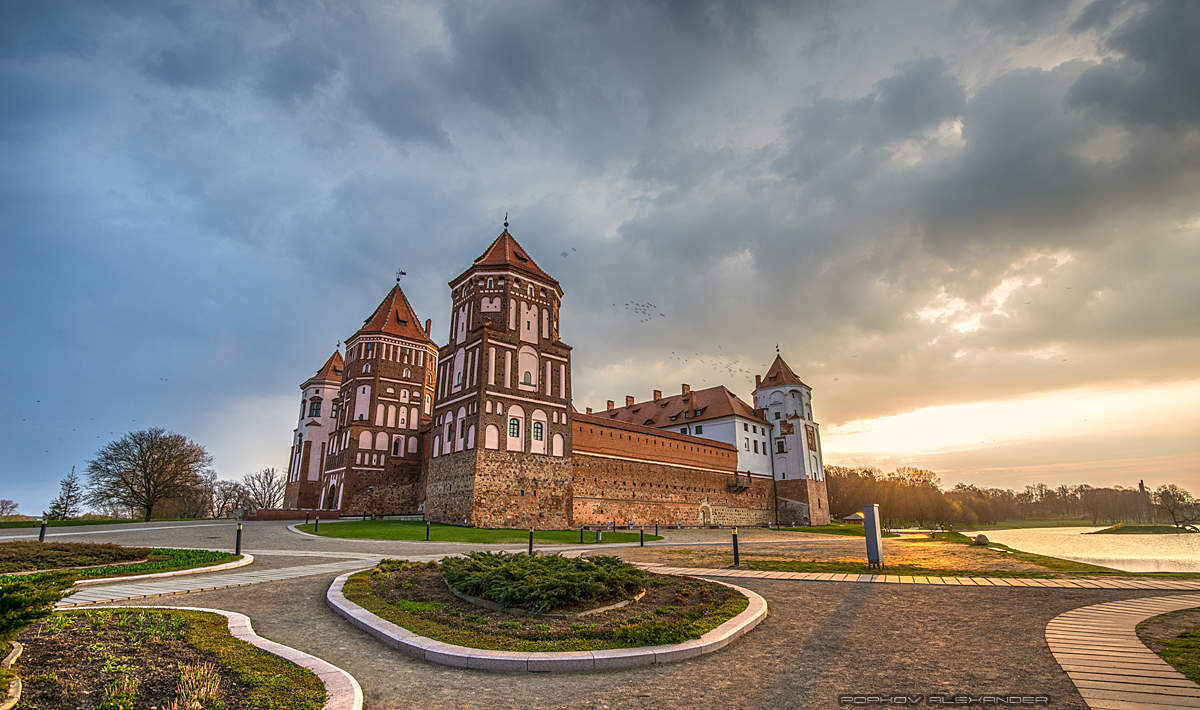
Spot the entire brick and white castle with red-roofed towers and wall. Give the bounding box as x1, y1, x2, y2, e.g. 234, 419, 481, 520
283, 227, 829, 529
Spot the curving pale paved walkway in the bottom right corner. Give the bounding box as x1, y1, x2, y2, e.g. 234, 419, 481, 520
1045, 594, 1200, 710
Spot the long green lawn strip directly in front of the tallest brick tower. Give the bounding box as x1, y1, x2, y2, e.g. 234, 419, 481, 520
296, 521, 662, 544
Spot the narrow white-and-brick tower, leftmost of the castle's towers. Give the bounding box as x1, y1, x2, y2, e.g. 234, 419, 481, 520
283, 350, 343, 509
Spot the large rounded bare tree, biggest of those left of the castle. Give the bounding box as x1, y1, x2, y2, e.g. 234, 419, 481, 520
88, 428, 212, 521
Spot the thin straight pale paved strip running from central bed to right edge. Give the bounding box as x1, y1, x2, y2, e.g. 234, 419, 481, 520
634, 562, 1200, 591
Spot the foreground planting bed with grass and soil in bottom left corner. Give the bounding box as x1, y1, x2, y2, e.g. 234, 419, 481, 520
17, 609, 325, 710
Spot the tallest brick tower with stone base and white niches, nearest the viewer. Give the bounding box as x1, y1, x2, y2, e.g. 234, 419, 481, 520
425, 222, 571, 528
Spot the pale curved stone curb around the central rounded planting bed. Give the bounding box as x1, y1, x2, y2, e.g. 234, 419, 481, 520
325, 567, 767, 673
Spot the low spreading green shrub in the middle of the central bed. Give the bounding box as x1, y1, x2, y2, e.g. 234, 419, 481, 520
442, 552, 646, 612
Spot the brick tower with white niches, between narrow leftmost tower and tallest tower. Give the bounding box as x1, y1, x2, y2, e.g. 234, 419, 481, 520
320, 279, 438, 513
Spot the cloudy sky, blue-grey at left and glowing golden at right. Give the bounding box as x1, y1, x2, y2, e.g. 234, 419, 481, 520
0, 0, 1200, 513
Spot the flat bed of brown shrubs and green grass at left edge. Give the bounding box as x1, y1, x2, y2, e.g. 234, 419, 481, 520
0, 541, 238, 578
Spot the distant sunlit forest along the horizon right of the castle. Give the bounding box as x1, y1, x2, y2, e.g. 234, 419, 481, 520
826, 467, 1200, 528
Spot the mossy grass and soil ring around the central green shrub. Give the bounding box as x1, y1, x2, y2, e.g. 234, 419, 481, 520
342, 558, 748, 651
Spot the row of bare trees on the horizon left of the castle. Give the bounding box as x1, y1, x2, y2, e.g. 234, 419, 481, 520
32, 428, 286, 521
